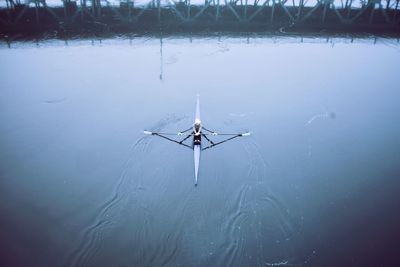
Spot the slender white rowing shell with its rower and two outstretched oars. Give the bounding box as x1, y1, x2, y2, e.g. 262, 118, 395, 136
143, 95, 250, 186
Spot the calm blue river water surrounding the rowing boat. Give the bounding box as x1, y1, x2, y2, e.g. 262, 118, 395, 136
0, 35, 400, 266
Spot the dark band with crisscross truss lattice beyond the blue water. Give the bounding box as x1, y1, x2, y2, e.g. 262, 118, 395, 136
0, 0, 400, 35
